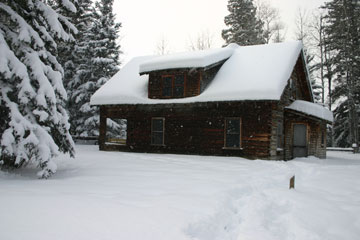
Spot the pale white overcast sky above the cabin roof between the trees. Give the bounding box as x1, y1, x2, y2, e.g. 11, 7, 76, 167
114, 0, 325, 62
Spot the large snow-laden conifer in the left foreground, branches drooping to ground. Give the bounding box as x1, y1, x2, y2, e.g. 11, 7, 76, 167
0, 0, 76, 178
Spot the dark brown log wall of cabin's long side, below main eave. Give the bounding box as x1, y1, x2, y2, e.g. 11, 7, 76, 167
100, 101, 273, 158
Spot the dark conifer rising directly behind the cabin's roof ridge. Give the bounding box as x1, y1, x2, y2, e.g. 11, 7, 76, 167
222, 0, 265, 45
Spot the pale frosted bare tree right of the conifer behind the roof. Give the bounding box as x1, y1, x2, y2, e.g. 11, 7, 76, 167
255, 0, 285, 43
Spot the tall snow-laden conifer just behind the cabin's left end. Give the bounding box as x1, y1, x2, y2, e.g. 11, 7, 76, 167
73, 0, 121, 136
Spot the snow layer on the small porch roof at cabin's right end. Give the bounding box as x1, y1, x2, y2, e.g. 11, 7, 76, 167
285, 100, 334, 122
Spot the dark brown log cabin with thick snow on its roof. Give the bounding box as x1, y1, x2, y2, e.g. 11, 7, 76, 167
91, 41, 333, 160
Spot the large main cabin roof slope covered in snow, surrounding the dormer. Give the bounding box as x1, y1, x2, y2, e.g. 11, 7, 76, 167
91, 41, 302, 105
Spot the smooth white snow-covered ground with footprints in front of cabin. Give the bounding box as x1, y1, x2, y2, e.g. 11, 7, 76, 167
0, 145, 360, 240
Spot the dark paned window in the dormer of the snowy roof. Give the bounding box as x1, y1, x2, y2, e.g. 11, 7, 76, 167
162, 74, 185, 98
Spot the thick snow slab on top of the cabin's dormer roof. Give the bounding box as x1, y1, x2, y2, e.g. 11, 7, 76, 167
139, 43, 239, 73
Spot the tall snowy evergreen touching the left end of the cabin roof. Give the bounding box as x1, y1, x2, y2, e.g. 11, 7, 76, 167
68, 0, 121, 136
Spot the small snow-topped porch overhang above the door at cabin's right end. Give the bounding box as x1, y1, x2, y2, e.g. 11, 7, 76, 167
285, 100, 334, 124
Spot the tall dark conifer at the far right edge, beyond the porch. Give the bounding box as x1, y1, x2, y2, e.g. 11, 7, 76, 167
324, 0, 360, 147
